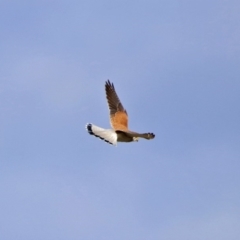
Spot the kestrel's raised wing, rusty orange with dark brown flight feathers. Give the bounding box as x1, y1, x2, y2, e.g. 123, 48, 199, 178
105, 80, 128, 131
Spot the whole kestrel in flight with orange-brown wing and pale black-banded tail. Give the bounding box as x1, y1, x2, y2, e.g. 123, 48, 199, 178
86, 80, 155, 145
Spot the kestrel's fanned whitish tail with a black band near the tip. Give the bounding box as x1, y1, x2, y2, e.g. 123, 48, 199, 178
86, 123, 117, 145
